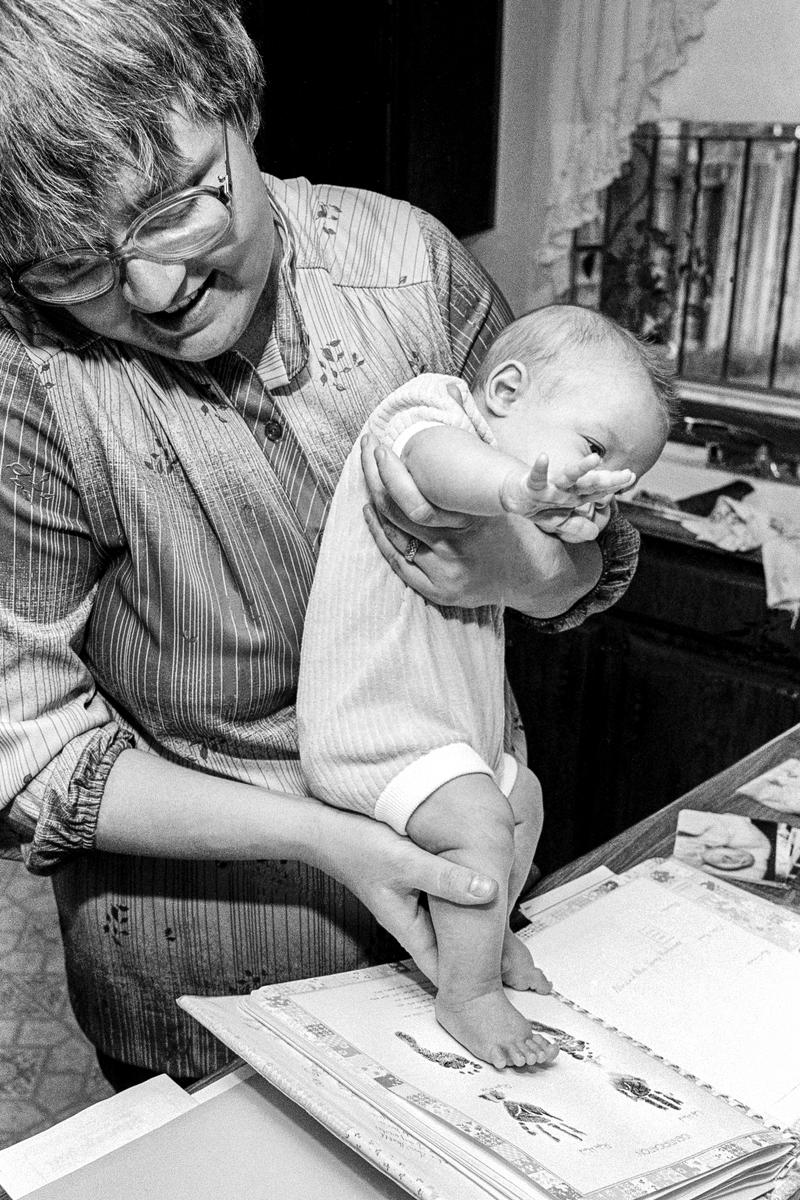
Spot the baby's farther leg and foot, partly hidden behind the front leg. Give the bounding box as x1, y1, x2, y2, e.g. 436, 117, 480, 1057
503, 766, 553, 992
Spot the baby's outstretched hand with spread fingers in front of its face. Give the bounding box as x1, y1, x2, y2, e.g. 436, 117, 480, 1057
500, 454, 636, 518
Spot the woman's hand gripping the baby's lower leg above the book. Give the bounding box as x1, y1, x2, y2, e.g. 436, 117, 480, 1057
317, 805, 498, 983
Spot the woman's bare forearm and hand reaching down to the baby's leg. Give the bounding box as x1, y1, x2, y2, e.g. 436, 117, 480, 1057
96, 750, 498, 979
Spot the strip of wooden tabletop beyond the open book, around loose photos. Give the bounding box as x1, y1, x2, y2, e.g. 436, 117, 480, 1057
529, 725, 800, 912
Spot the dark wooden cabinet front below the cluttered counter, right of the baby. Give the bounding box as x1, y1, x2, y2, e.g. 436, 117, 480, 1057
507, 520, 800, 871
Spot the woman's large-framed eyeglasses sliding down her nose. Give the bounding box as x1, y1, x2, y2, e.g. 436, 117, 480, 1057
12, 121, 233, 304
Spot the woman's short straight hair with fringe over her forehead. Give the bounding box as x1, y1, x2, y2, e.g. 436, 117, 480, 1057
0, 0, 263, 266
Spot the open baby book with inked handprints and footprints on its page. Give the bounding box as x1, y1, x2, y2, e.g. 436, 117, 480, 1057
180, 864, 800, 1200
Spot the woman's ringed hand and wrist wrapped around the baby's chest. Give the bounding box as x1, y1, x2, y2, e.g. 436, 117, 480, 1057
361, 436, 602, 618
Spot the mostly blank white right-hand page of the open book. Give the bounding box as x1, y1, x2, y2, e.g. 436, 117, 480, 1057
523, 878, 800, 1126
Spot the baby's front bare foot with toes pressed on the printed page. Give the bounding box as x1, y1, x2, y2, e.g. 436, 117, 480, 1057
437, 988, 558, 1068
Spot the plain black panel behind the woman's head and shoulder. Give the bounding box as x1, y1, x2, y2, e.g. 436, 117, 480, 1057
237, 0, 503, 236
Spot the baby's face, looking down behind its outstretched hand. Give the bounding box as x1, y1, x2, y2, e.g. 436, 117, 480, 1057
493, 364, 667, 479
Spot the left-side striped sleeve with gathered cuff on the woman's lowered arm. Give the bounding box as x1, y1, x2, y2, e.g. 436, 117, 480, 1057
0, 340, 133, 874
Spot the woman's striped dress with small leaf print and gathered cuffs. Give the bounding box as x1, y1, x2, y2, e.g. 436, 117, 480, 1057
0, 178, 637, 1076
